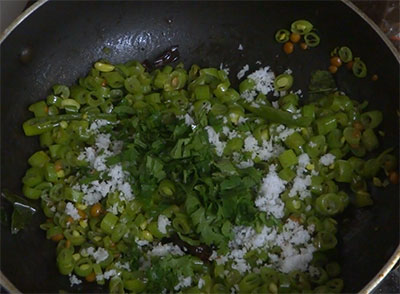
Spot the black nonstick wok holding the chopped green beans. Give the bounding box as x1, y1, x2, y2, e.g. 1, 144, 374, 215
1, 1, 399, 293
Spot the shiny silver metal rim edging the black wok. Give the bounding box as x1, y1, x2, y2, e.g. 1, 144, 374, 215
0, 0, 400, 294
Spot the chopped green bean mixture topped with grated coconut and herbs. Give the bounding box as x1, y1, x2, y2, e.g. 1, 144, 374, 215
23, 56, 397, 293
